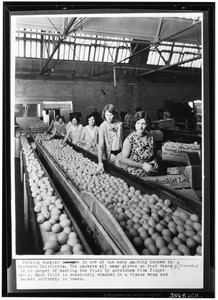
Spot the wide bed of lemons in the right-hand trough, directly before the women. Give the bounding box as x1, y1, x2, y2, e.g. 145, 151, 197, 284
33, 139, 202, 255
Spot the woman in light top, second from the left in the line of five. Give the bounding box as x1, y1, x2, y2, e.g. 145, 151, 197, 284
63, 114, 83, 145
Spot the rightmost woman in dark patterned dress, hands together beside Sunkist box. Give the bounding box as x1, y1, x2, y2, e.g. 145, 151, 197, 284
120, 111, 158, 177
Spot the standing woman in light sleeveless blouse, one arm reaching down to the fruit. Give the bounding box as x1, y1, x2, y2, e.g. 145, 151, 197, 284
97, 104, 123, 173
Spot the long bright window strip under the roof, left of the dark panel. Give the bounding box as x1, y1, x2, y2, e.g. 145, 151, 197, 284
16, 29, 131, 63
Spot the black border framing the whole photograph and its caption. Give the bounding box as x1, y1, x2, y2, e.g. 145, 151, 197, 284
2, 2, 215, 298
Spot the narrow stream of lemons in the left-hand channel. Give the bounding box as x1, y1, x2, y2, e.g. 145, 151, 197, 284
21, 136, 85, 255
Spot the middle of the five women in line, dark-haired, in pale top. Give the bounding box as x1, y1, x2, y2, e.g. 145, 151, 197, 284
80, 113, 99, 148
